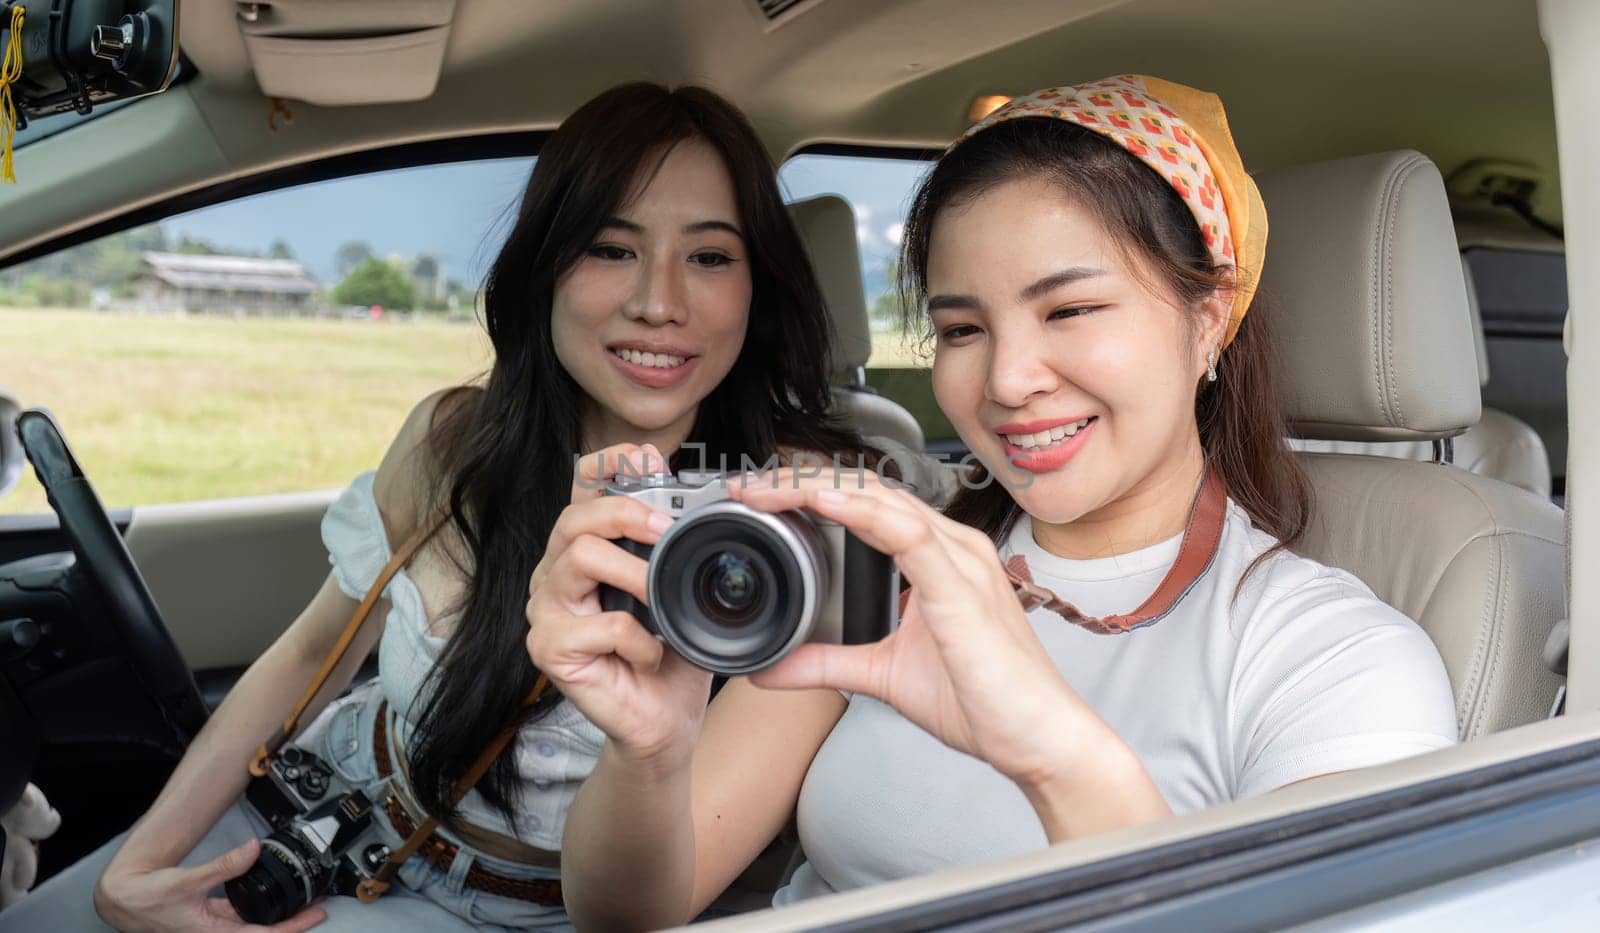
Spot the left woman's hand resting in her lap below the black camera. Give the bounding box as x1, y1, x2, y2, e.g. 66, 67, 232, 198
94, 839, 328, 933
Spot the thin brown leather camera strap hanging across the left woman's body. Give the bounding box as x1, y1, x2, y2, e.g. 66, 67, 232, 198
250, 517, 550, 903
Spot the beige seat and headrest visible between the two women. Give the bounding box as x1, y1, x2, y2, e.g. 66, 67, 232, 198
789, 195, 955, 504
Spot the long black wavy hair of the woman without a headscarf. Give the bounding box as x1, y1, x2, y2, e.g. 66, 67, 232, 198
411, 83, 862, 818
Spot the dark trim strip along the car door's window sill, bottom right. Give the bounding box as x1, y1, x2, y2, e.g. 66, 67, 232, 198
829, 741, 1600, 933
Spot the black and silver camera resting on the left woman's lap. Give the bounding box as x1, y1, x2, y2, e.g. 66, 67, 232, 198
222, 746, 389, 923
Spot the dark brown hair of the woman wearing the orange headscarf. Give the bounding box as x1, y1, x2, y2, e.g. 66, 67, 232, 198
899, 117, 1310, 547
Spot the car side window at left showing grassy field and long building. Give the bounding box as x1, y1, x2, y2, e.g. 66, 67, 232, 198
0, 158, 533, 514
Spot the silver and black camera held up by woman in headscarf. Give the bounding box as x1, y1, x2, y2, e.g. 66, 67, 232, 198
600, 471, 899, 675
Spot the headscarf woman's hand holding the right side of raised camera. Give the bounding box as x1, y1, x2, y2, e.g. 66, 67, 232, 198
730, 471, 1120, 791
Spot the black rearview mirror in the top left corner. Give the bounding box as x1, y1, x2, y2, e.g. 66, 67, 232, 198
0, 0, 178, 128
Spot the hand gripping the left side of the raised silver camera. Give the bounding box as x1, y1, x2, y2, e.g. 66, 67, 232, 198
526, 443, 710, 765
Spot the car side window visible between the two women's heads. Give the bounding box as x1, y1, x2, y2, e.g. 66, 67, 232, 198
779, 152, 955, 450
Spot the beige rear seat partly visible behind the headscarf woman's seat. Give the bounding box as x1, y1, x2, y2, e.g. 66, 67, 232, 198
1290, 251, 1550, 499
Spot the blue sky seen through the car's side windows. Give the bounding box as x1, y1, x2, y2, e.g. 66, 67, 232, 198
166, 155, 925, 294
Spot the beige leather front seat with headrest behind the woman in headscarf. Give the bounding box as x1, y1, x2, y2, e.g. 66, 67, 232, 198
1260, 150, 1565, 738
